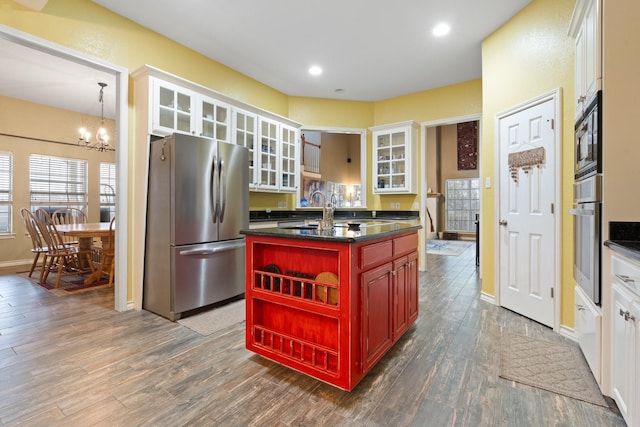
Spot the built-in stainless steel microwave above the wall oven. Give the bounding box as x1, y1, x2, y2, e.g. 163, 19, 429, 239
574, 91, 602, 180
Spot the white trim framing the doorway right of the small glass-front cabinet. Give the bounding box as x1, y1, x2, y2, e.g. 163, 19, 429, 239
418, 113, 482, 278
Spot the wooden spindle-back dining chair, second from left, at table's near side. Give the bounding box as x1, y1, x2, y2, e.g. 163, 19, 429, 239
36, 209, 95, 288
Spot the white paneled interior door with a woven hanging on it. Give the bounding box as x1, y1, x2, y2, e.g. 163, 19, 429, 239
498, 94, 557, 327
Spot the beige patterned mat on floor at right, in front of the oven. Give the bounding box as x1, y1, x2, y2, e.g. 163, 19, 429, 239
500, 334, 608, 407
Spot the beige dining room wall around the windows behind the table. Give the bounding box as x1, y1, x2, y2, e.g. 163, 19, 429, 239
0, 96, 115, 265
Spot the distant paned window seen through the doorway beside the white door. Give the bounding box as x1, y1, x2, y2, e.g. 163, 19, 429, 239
445, 178, 480, 236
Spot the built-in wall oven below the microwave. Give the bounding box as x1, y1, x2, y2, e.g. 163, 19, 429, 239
569, 175, 602, 305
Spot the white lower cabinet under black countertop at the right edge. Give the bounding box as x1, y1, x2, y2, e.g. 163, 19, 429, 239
611, 256, 640, 426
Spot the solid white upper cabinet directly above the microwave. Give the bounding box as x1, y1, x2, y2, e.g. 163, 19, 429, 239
569, 0, 602, 120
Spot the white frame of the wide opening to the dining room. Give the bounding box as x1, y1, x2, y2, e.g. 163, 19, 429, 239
0, 24, 133, 311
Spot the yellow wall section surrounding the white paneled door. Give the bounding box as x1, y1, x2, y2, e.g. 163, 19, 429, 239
479, 0, 575, 327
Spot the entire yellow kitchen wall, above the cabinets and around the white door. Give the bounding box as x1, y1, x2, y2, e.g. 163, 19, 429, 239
0, 0, 574, 334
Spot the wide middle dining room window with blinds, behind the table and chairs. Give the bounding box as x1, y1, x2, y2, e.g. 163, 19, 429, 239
29, 154, 88, 213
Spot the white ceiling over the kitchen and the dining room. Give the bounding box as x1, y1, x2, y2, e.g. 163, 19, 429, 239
0, 0, 531, 118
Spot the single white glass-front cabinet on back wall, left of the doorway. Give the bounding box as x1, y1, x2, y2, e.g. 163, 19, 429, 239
370, 121, 418, 194
